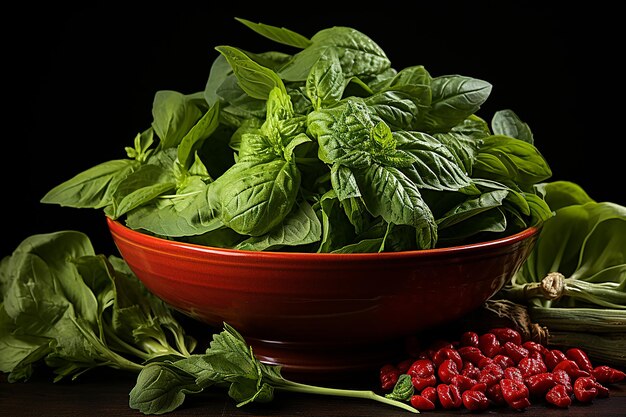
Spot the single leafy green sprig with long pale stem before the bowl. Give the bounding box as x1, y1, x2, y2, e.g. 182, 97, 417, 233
129, 323, 418, 414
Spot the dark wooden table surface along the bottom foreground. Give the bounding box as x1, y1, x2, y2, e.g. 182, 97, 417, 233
0, 369, 626, 417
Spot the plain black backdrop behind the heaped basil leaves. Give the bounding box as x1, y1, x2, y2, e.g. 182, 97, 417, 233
0, 1, 626, 257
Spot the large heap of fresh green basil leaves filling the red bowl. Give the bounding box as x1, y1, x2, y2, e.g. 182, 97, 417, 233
42, 19, 551, 252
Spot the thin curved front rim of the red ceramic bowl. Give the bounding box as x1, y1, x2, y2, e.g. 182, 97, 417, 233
106, 216, 542, 260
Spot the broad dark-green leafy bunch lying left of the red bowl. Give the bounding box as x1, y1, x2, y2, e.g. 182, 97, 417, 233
0, 231, 196, 382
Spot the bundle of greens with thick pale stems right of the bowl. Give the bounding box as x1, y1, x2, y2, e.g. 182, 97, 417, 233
494, 181, 626, 366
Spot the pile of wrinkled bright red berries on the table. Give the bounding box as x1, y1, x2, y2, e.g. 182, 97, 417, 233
380, 327, 626, 411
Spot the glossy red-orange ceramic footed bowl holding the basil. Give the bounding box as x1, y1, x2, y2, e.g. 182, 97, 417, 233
107, 218, 539, 375
